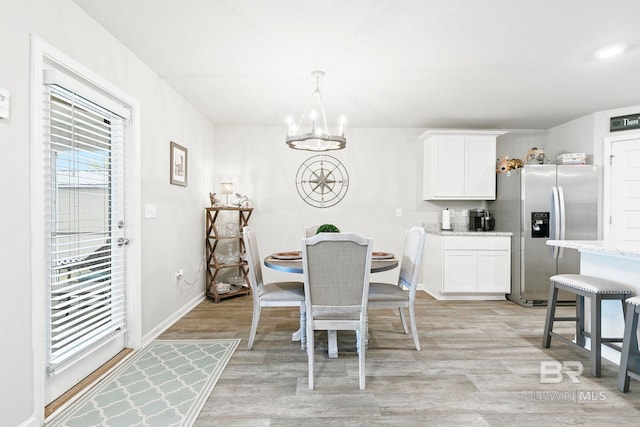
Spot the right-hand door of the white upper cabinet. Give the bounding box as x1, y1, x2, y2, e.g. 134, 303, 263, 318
464, 136, 496, 200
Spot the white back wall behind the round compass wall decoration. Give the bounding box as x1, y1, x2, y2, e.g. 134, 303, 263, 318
212, 127, 426, 288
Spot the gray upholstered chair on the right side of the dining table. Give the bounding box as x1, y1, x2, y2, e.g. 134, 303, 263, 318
369, 227, 426, 350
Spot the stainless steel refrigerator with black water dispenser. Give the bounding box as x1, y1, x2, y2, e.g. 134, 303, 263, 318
488, 165, 598, 306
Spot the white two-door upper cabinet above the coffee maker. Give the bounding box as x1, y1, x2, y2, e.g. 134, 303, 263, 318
421, 129, 507, 200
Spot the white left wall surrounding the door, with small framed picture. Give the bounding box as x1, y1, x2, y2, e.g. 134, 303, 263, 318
0, 0, 213, 426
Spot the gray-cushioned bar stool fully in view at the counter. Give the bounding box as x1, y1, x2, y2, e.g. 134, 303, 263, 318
542, 274, 631, 377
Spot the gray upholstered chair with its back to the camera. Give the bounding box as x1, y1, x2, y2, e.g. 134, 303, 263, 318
302, 233, 373, 390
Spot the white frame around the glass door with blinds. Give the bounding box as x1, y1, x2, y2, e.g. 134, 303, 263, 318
31, 35, 142, 425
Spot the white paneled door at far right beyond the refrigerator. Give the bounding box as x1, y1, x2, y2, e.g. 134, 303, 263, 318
605, 138, 640, 242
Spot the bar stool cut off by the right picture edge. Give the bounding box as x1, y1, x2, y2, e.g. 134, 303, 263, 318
618, 297, 640, 393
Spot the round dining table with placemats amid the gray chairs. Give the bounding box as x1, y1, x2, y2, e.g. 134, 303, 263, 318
264, 251, 399, 359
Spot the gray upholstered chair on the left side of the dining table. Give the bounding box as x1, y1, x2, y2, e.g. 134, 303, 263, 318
242, 226, 306, 349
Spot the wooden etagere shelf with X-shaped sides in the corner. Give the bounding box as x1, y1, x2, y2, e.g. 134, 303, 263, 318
205, 206, 253, 302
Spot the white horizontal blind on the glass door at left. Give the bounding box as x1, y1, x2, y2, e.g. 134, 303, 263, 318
44, 84, 126, 375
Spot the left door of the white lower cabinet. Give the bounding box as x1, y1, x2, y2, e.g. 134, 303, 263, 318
442, 251, 478, 293
